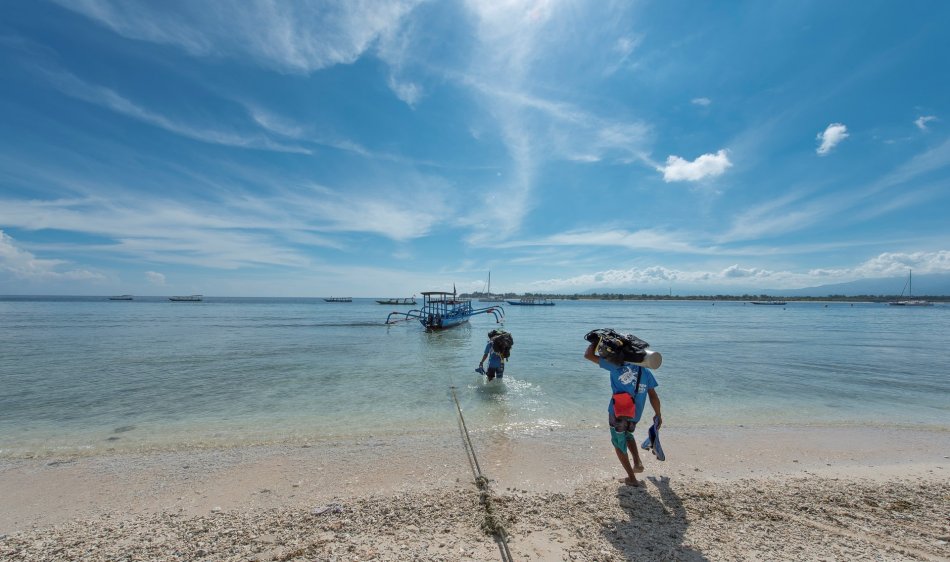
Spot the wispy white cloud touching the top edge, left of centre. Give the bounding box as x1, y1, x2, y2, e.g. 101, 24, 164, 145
57, 0, 420, 73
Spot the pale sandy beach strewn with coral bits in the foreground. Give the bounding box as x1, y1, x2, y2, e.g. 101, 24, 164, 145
0, 427, 950, 561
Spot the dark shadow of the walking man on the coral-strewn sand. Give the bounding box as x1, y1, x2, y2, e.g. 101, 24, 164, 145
603, 476, 708, 562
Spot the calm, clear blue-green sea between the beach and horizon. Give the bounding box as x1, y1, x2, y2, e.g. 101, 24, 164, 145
0, 296, 950, 458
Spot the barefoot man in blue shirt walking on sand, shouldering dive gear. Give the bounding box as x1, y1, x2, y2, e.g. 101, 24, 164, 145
584, 334, 663, 486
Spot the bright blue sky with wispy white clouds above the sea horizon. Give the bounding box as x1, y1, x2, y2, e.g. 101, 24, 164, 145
0, 0, 950, 297
